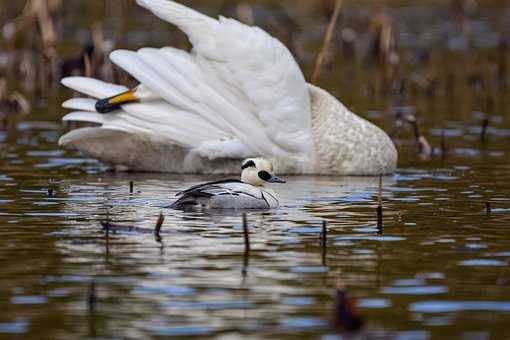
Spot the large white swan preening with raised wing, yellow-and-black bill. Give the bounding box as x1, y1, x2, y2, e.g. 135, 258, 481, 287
59, 0, 397, 175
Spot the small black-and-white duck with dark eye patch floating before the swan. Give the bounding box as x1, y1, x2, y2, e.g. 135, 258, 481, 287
170, 158, 284, 210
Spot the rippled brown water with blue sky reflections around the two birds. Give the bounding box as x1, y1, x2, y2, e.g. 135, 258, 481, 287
0, 116, 510, 339
